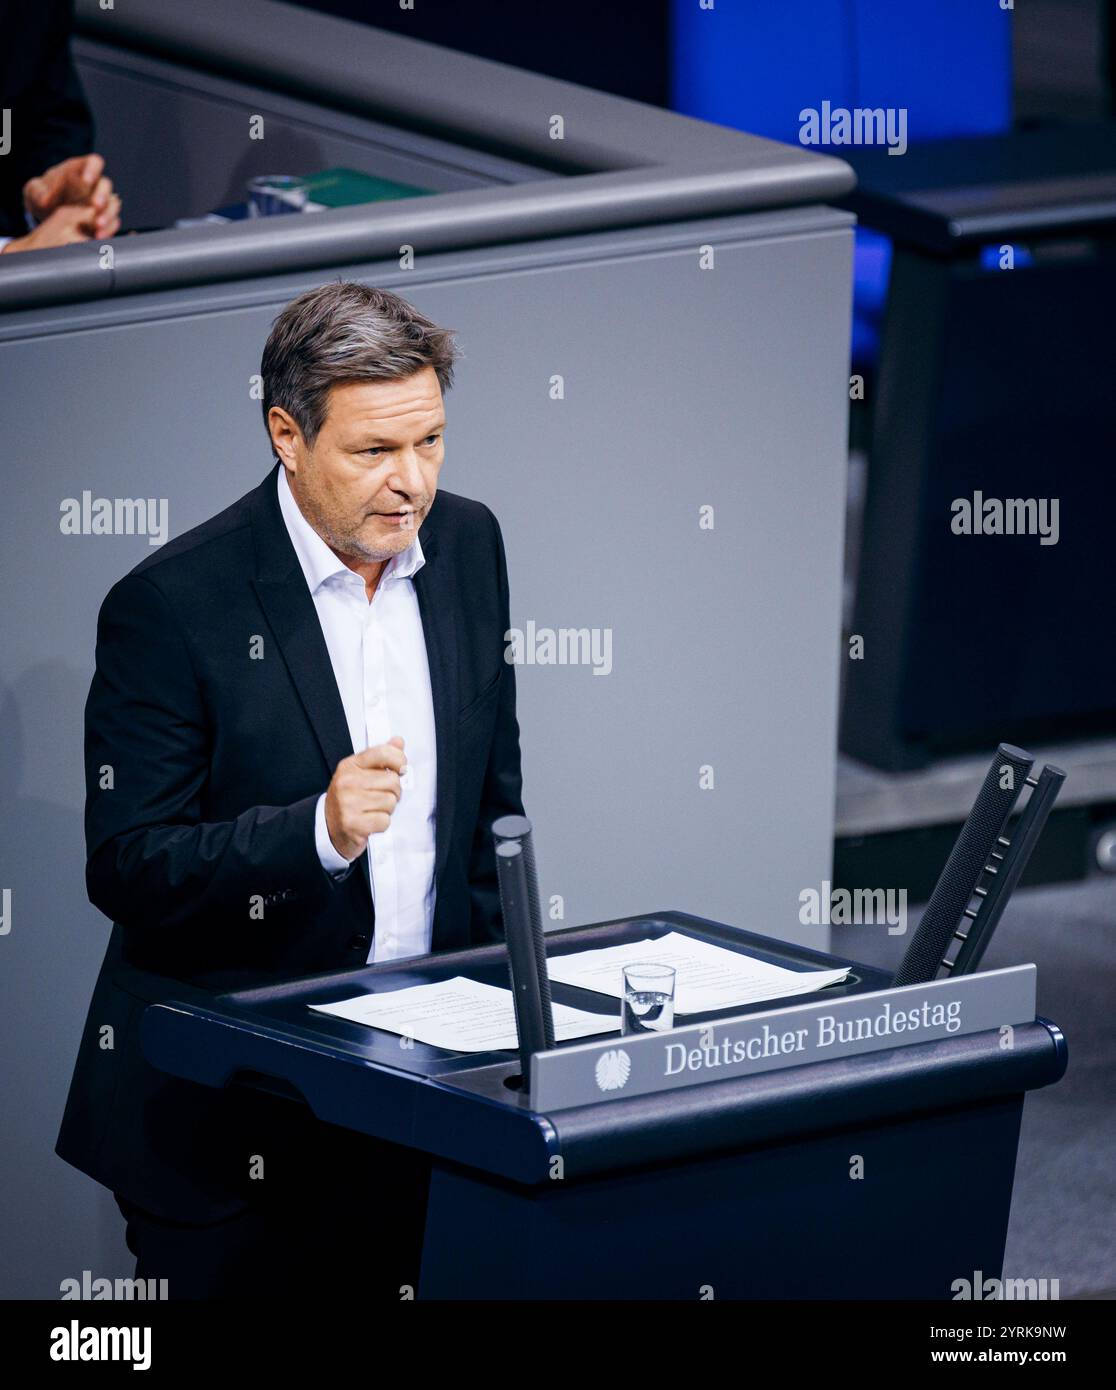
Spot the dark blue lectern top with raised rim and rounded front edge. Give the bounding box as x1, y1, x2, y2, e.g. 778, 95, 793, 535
142, 910, 1065, 1183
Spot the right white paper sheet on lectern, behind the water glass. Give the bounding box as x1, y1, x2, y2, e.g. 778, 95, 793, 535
546, 931, 849, 1013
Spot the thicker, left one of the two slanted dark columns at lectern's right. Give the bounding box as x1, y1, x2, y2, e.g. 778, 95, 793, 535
892, 744, 1034, 986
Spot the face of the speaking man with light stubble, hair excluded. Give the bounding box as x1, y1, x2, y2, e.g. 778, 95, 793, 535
268, 367, 446, 564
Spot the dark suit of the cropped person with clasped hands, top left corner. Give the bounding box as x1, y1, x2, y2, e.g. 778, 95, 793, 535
0, 0, 93, 236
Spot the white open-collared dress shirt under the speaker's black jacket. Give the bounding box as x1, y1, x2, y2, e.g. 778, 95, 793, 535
278, 467, 438, 962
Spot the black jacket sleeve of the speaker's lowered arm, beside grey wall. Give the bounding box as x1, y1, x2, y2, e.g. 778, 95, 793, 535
468, 512, 524, 944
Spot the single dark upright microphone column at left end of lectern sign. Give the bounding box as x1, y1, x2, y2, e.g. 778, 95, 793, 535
492, 816, 555, 1088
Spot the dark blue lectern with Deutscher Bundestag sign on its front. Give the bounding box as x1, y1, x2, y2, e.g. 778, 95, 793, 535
142, 912, 1066, 1300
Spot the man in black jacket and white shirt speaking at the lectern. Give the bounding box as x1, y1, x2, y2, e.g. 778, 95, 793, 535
57, 284, 523, 1300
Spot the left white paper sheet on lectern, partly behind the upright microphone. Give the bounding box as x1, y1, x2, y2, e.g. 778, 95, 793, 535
310, 974, 620, 1052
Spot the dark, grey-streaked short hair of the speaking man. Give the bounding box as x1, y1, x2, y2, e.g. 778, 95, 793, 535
260, 281, 459, 445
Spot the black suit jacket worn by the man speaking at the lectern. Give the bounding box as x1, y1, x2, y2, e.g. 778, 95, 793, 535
57, 464, 523, 1220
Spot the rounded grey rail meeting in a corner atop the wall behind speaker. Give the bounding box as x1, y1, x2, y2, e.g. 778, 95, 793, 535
0, 0, 853, 307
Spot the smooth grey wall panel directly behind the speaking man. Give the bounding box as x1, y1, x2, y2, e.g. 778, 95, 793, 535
0, 211, 851, 1297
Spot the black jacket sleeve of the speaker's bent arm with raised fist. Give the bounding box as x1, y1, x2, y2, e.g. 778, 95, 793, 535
85, 575, 332, 931
